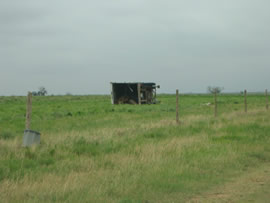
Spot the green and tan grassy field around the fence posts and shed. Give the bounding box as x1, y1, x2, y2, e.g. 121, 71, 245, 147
0, 95, 270, 203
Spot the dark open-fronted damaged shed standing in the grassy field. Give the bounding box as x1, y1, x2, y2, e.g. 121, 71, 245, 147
111, 82, 159, 104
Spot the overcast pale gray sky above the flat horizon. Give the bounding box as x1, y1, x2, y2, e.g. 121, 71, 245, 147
0, 0, 270, 95
